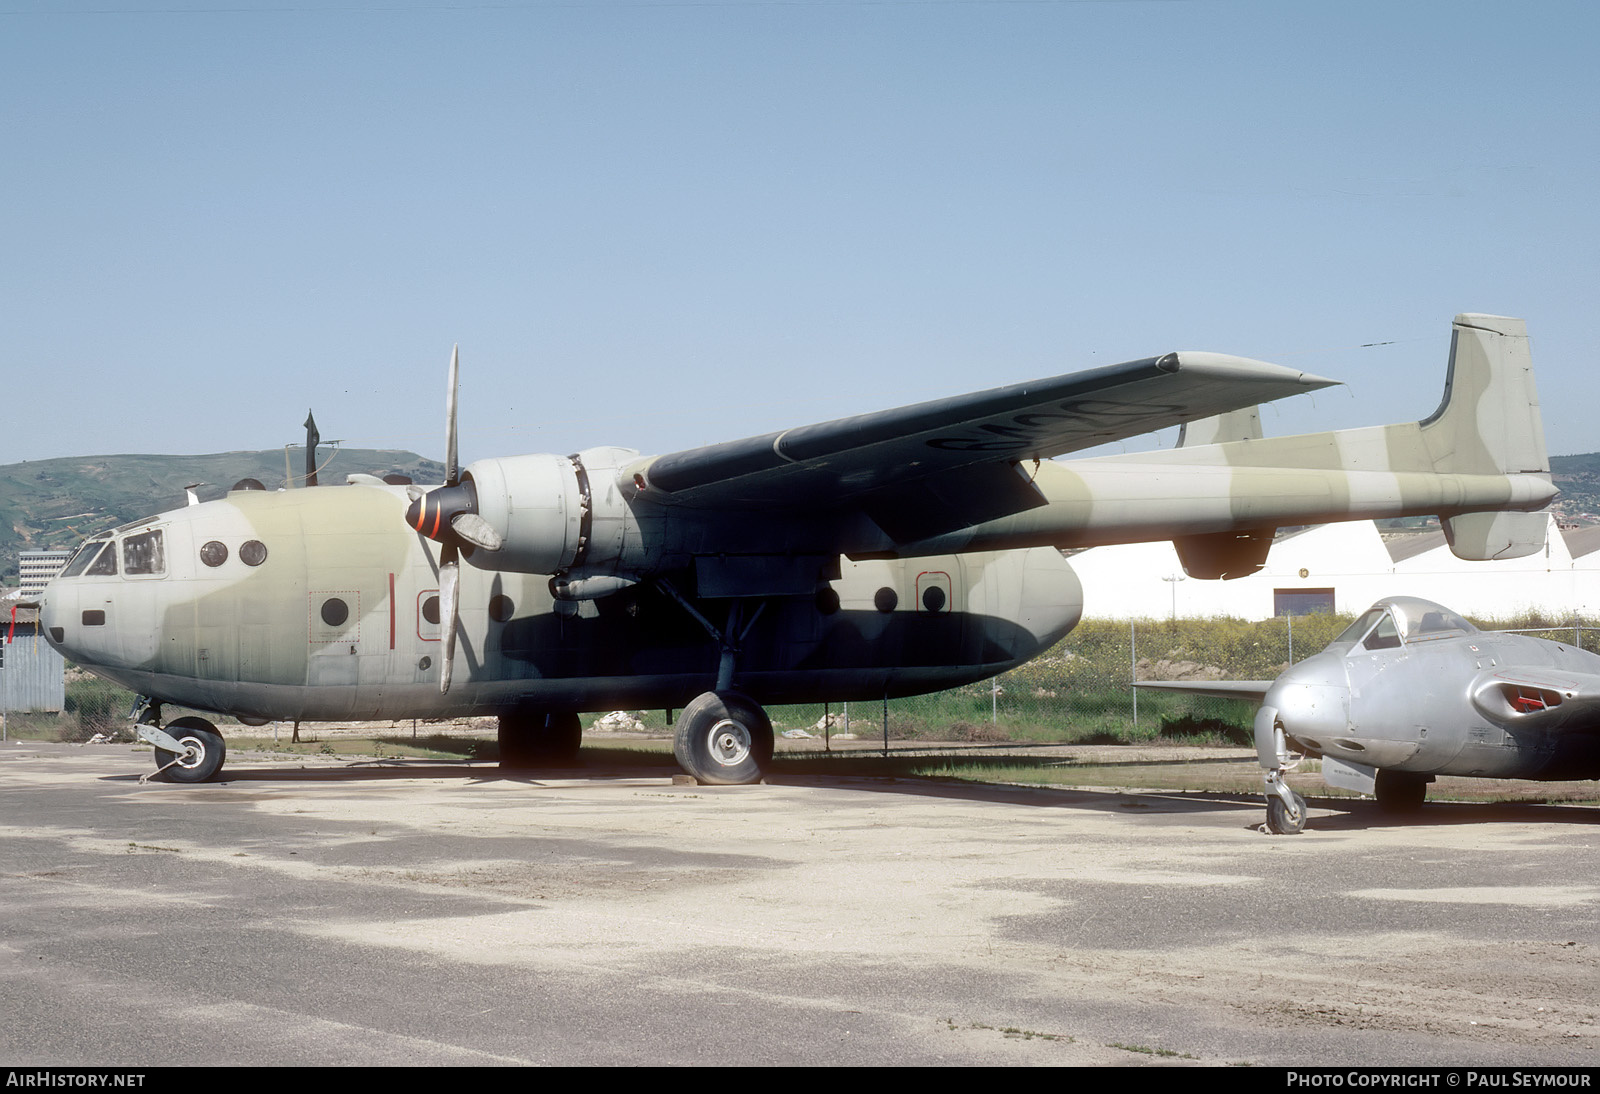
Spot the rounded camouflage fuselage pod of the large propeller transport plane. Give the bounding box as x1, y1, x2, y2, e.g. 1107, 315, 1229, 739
42, 481, 1082, 721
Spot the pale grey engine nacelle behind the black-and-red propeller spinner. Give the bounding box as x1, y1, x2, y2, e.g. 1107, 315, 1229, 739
461, 448, 638, 574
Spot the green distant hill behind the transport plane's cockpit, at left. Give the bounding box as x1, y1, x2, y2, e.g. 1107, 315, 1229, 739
0, 448, 445, 585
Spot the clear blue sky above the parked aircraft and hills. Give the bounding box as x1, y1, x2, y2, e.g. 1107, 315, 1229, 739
0, 0, 1600, 470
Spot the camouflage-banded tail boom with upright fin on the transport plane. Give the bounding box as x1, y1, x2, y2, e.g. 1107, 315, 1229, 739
870, 315, 1557, 577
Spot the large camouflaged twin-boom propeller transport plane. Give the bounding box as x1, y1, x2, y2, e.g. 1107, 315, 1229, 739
40, 315, 1555, 784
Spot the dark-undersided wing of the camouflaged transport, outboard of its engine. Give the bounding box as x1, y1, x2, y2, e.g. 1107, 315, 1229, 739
624, 352, 1334, 524
